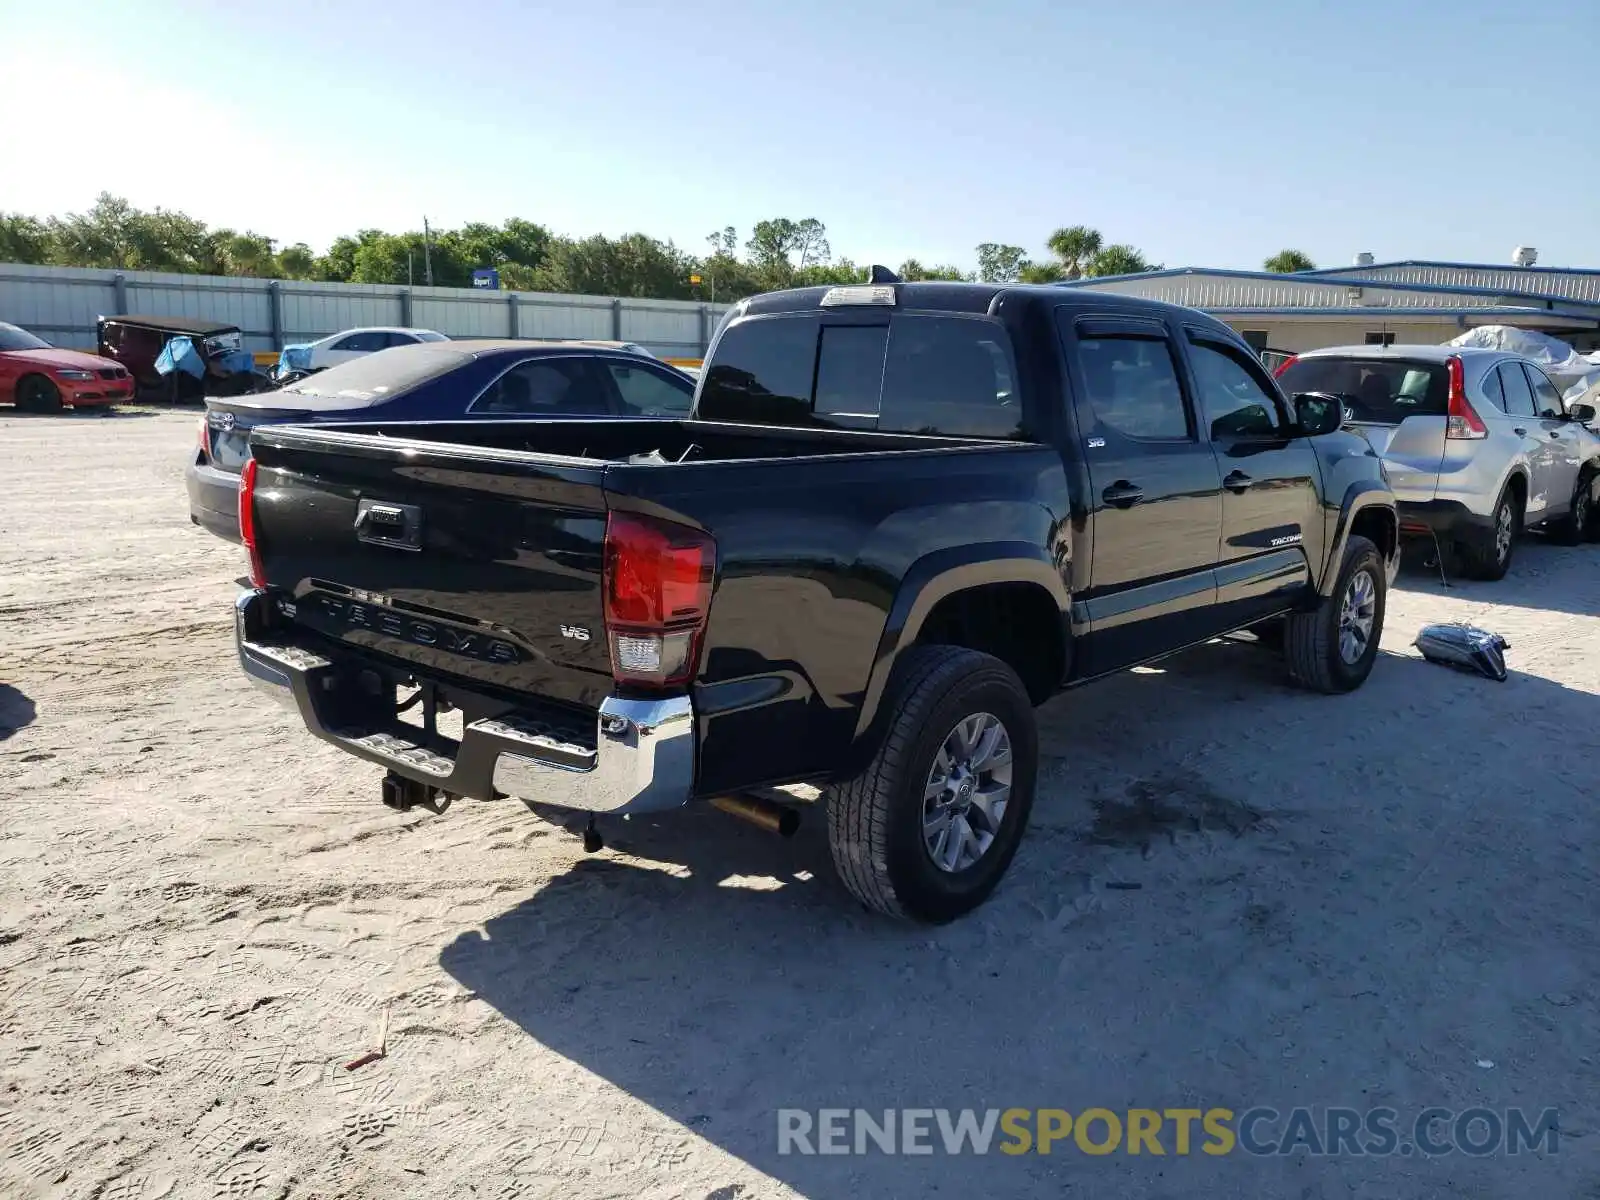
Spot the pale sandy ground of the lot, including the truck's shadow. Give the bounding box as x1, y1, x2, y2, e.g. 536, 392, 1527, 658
0, 413, 1600, 1200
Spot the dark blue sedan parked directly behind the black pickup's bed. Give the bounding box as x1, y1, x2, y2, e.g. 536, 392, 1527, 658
187, 341, 694, 541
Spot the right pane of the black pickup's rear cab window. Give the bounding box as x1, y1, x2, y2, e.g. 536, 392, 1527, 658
883, 317, 1022, 440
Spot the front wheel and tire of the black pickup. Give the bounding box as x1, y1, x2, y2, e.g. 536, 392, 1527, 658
1283, 536, 1387, 694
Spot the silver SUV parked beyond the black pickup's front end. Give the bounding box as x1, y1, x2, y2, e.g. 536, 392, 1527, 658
1277, 346, 1600, 579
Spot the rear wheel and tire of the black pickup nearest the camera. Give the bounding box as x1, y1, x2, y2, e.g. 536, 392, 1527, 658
826, 646, 1038, 925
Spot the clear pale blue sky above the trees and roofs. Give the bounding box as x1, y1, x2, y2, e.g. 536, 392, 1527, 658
0, 0, 1600, 267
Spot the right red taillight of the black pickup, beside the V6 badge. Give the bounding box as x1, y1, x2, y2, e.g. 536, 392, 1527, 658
601, 512, 717, 688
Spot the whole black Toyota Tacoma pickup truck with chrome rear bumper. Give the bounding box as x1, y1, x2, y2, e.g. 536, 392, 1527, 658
237, 283, 1398, 922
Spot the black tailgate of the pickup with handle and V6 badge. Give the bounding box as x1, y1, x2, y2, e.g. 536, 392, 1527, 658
251, 426, 611, 709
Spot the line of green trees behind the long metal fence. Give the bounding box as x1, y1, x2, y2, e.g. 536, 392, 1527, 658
0, 194, 1310, 301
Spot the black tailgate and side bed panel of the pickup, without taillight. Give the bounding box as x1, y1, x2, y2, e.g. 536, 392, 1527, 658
251, 419, 1066, 793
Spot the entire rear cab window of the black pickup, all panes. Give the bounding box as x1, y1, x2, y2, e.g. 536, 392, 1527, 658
696, 314, 1024, 440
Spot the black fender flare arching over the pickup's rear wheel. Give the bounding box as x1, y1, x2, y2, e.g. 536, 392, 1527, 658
854, 542, 1072, 742
